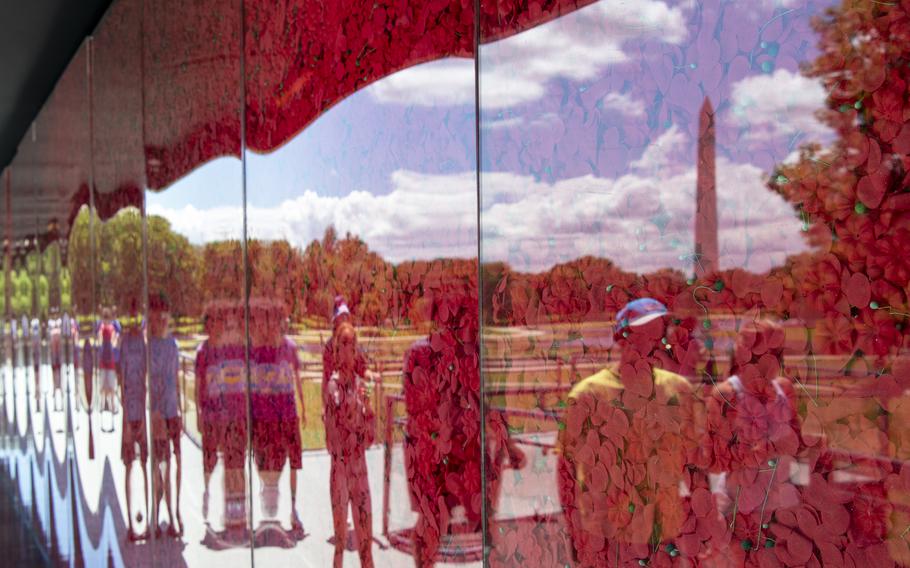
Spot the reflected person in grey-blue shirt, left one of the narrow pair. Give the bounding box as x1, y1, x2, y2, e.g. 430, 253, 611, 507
117, 305, 148, 540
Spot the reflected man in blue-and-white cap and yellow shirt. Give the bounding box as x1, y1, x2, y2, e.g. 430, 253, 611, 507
558, 298, 694, 566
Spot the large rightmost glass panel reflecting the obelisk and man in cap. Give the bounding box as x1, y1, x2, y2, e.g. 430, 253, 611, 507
479, 0, 910, 566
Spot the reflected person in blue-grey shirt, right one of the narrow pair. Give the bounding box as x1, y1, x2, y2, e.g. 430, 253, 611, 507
149, 296, 183, 536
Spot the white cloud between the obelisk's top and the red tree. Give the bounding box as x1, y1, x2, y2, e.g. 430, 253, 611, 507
730, 69, 831, 142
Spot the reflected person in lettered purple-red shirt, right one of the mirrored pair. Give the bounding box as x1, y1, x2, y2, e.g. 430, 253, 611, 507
250, 299, 303, 533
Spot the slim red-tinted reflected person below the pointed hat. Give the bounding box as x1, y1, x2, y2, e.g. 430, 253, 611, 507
324, 322, 375, 568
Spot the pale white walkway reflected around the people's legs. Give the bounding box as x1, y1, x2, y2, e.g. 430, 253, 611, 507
3, 366, 559, 567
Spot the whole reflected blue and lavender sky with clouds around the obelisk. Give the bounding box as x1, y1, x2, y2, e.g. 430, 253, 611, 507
149, 0, 831, 272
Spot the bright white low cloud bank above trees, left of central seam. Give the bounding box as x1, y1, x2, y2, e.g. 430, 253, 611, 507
149, 170, 477, 262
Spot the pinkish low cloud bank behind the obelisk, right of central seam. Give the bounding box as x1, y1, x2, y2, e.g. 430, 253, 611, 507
482, 158, 806, 273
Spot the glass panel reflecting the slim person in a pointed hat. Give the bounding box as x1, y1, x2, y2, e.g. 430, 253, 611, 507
242, 2, 482, 566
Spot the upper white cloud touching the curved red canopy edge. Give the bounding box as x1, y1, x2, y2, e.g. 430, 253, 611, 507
368, 0, 686, 109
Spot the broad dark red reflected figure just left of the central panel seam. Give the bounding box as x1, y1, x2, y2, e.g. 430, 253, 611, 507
402, 275, 480, 566
